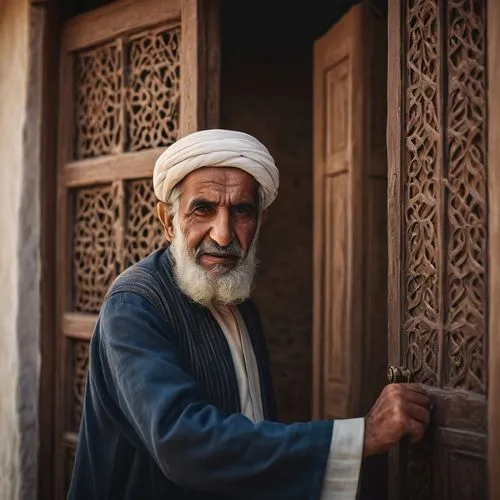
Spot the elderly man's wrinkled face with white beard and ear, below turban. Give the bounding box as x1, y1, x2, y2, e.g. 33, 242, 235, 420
159, 167, 259, 304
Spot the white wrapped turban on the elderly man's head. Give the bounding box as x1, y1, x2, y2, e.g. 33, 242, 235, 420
153, 129, 279, 209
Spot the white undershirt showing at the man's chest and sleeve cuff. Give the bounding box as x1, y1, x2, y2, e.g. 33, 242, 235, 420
210, 306, 365, 500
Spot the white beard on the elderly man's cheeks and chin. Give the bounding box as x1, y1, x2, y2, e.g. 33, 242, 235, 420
170, 217, 260, 306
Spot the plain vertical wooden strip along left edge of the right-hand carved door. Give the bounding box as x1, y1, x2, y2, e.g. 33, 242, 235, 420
387, 0, 403, 500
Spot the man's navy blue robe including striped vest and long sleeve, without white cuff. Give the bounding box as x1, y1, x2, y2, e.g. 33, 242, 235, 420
68, 250, 333, 500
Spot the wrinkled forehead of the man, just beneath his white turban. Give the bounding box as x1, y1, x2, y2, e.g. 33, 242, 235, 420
181, 167, 258, 203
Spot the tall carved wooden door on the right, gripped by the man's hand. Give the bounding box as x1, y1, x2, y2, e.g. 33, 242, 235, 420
388, 0, 488, 500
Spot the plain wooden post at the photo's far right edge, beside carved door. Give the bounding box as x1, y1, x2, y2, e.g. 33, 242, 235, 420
486, 0, 500, 492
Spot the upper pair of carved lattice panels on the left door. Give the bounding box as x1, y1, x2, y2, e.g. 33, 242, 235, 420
75, 23, 180, 159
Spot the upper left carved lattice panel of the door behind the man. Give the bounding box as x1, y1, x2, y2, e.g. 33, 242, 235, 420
75, 42, 123, 159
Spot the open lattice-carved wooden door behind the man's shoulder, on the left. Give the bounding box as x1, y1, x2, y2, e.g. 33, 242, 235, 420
55, 0, 219, 499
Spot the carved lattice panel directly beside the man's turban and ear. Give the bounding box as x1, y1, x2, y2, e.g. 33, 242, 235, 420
124, 178, 166, 267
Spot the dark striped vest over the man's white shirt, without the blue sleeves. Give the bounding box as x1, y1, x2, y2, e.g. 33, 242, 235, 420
106, 249, 276, 420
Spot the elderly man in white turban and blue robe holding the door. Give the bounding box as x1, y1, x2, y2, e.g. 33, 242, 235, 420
68, 130, 429, 500
